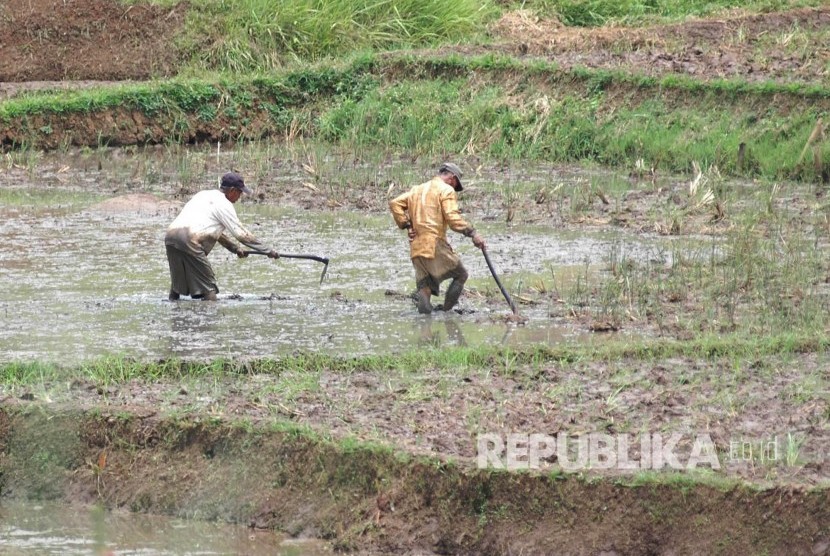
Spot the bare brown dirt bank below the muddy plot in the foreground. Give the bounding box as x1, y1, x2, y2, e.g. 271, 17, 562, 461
0, 405, 830, 554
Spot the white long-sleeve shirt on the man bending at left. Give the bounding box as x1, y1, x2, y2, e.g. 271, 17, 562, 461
164, 189, 270, 255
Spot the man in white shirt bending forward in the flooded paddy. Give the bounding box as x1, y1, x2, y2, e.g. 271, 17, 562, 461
164, 172, 279, 301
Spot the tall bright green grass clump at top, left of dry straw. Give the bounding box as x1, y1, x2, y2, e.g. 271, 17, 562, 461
167, 0, 496, 72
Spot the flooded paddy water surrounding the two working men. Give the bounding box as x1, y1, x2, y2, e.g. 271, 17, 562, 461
0, 147, 716, 364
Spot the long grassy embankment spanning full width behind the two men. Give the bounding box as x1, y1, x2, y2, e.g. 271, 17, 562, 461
0, 55, 830, 180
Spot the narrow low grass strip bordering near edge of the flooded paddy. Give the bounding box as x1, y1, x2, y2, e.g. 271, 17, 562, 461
0, 331, 830, 388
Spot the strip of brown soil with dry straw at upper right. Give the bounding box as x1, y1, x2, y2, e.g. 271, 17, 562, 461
493, 7, 830, 84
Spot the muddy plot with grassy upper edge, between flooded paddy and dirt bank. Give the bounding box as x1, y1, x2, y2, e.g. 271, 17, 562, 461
0, 334, 830, 486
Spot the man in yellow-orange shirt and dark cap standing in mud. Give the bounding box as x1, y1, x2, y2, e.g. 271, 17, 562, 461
389, 162, 485, 314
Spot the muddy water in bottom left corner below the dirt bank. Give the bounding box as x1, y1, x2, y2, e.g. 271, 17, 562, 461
0, 500, 332, 556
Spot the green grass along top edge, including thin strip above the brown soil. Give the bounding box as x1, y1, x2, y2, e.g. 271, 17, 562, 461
133, 0, 822, 72
